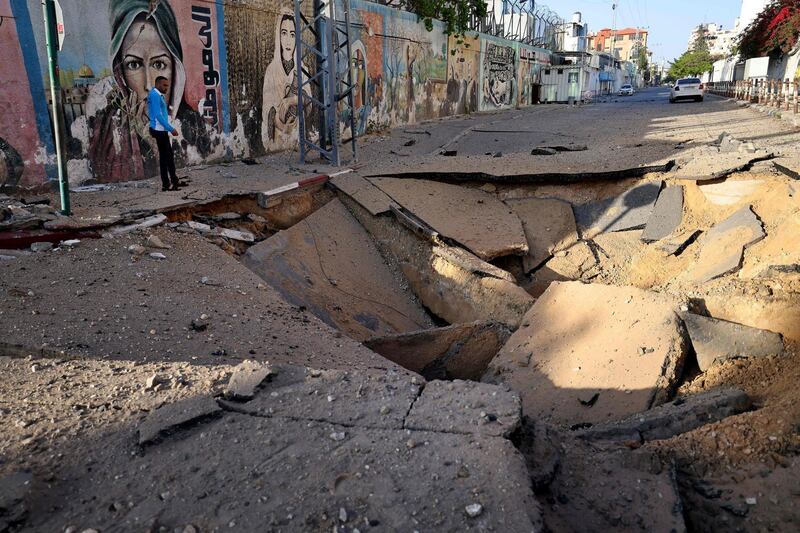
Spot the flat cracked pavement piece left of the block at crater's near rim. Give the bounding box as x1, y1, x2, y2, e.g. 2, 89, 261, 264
223, 365, 422, 429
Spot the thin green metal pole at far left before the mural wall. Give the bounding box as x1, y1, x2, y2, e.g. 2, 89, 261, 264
42, 0, 70, 215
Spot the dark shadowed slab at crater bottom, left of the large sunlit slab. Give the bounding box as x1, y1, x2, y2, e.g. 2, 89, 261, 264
364, 322, 510, 380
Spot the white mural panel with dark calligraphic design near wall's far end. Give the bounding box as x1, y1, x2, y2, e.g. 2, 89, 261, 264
480, 38, 517, 111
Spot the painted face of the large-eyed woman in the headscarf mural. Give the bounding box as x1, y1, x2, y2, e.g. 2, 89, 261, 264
120, 18, 173, 100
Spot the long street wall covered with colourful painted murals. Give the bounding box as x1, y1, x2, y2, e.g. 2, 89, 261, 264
0, 0, 549, 187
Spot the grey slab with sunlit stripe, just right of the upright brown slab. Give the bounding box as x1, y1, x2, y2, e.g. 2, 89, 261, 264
575, 183, 661, 236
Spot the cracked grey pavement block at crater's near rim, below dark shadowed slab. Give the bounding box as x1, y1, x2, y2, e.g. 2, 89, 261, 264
405, 380, 522, 437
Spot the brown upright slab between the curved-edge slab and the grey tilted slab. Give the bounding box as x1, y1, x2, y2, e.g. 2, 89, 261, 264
506, 198, 578, 273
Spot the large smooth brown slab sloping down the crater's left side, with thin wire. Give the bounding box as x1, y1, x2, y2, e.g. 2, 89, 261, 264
242, 199, 433, 340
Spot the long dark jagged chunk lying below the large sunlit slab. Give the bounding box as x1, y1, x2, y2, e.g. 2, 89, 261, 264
575, 387, 752, 443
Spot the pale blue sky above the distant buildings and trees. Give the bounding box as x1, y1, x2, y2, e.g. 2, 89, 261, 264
556, 0, 741, 63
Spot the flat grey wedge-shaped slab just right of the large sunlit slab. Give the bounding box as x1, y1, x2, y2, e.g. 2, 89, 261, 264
681, 313, 784, 372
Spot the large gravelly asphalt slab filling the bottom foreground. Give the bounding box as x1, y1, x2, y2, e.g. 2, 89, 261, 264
36, 413, 543, 531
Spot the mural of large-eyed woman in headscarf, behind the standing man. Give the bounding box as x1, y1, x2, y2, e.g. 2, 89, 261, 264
88, 0, 211, 181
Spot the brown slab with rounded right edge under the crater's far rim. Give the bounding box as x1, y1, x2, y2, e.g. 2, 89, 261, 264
370, 178, 528, 261
